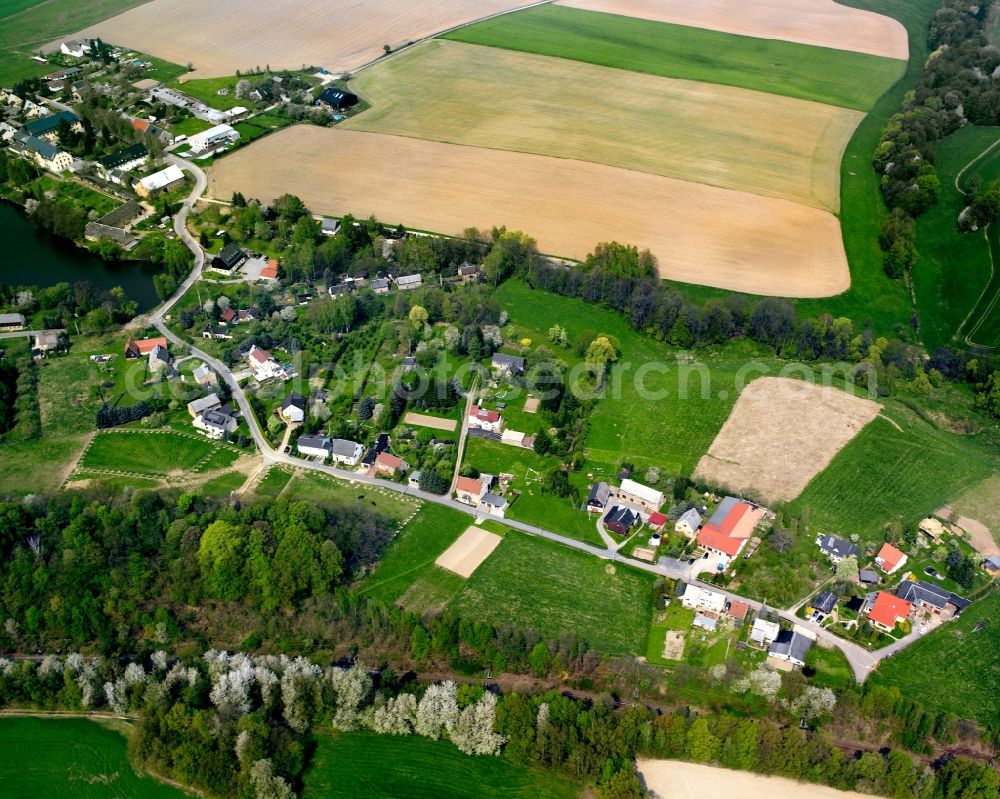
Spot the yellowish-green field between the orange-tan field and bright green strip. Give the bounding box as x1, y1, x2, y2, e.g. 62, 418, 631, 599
344, 41, 864, 212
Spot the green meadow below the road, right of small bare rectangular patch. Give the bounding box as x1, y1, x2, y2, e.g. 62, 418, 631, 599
450, 531, 654, 655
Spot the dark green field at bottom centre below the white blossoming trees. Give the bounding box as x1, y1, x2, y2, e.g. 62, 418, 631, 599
302, 733, 580, 799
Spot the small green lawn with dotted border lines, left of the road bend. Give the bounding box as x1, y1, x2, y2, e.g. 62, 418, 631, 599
80, 430, 220, 476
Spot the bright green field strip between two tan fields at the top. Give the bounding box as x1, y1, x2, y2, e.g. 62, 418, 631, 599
444, 5, 905, 111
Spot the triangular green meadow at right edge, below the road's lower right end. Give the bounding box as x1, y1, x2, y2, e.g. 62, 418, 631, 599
871, 590, 1000, 726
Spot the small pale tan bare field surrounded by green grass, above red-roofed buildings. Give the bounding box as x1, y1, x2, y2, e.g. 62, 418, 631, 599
694, 377, 882, 502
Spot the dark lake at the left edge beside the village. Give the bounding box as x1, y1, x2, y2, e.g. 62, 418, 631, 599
0, 202, 159, 311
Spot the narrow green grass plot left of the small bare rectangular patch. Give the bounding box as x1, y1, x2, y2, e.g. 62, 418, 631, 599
358, 503, 471, 603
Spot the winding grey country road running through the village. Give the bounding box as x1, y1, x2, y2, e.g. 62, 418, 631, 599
149, 155, 904, 683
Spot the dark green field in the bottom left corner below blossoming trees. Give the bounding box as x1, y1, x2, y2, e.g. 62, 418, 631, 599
0, 718, 189, 799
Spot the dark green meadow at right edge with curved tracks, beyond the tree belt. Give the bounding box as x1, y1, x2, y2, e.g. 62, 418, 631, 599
913, 125, 1000, 349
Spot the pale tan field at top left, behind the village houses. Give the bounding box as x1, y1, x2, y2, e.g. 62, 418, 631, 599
61, 0, 524, 78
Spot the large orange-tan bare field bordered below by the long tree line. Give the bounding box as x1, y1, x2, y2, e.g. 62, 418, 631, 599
209, 126, 850, 297
